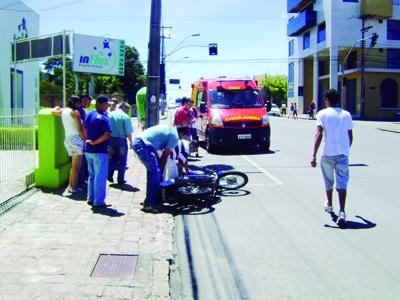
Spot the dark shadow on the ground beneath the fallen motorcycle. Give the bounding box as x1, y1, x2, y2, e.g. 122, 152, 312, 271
157, 197, 221, 216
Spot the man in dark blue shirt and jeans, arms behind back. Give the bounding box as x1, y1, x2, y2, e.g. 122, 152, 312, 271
85, 95, 112, 207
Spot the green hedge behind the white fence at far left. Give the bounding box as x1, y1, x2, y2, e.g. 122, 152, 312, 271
0, 127, 38, 150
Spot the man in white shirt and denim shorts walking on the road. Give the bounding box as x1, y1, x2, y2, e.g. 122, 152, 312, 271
311, 89, 353, 226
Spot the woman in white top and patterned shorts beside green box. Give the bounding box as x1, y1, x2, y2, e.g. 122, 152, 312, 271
52, 95, 86, 196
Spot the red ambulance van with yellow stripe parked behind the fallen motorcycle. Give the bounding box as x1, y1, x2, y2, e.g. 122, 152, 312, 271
192, 77, 271, 153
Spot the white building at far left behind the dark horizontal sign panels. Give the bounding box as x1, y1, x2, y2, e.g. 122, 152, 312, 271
0, 1, 39, 110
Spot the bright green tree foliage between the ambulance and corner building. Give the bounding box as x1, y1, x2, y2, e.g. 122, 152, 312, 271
260, 75, 287, 103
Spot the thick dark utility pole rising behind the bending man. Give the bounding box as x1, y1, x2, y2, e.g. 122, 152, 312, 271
145, 0, 161, 128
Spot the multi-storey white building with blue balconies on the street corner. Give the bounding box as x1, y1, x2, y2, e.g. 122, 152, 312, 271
287, 0, 400, 119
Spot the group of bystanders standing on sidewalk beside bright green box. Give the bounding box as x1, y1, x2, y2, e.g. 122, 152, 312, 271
52, 95, 133, 207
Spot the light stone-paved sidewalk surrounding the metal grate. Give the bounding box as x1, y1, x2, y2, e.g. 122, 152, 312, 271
0, 147, 173, 300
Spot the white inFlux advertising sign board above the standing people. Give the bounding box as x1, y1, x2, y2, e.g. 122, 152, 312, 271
72, 34, 125, 76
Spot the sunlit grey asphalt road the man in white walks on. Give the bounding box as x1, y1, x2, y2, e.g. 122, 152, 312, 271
171, 118, 400, 299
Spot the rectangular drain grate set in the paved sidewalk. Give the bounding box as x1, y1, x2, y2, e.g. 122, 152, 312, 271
90, 254, 139, 278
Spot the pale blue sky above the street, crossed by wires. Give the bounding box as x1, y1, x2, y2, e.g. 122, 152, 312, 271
20, 0, 288, 100
